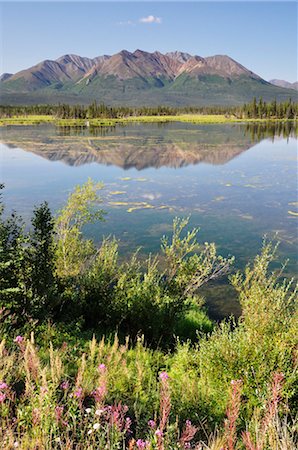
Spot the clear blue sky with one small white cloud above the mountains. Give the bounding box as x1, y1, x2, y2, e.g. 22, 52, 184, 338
1, 1, 297, 82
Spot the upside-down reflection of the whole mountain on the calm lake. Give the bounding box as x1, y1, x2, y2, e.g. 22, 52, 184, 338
1, 124, 296, 170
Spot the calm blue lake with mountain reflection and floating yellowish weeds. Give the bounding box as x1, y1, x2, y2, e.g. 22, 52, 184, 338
0, 122, 298, 318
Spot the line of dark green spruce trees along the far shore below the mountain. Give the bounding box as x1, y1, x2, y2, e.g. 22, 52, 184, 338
0, 98, 298, 119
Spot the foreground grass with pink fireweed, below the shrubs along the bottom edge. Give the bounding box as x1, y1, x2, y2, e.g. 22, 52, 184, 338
0, 334, 296, 450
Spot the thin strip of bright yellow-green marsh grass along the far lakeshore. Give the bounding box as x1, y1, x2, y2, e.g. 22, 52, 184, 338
0, 114, 296, 127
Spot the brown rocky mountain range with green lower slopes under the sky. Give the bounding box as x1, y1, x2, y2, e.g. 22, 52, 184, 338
0, 50, 297, 106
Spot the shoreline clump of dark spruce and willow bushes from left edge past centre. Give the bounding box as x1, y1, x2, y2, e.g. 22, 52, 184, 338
0, 180, 233, 346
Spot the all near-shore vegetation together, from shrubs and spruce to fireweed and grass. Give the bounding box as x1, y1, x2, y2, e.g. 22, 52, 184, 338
0, 180, 298, 450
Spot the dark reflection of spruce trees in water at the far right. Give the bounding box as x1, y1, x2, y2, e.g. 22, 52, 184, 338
244, 121, 298, 142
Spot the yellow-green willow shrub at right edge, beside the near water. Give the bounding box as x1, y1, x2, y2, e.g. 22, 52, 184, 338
199, 242, 298, 417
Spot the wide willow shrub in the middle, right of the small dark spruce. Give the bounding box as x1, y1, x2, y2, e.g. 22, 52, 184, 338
55, 180, 233, 346
